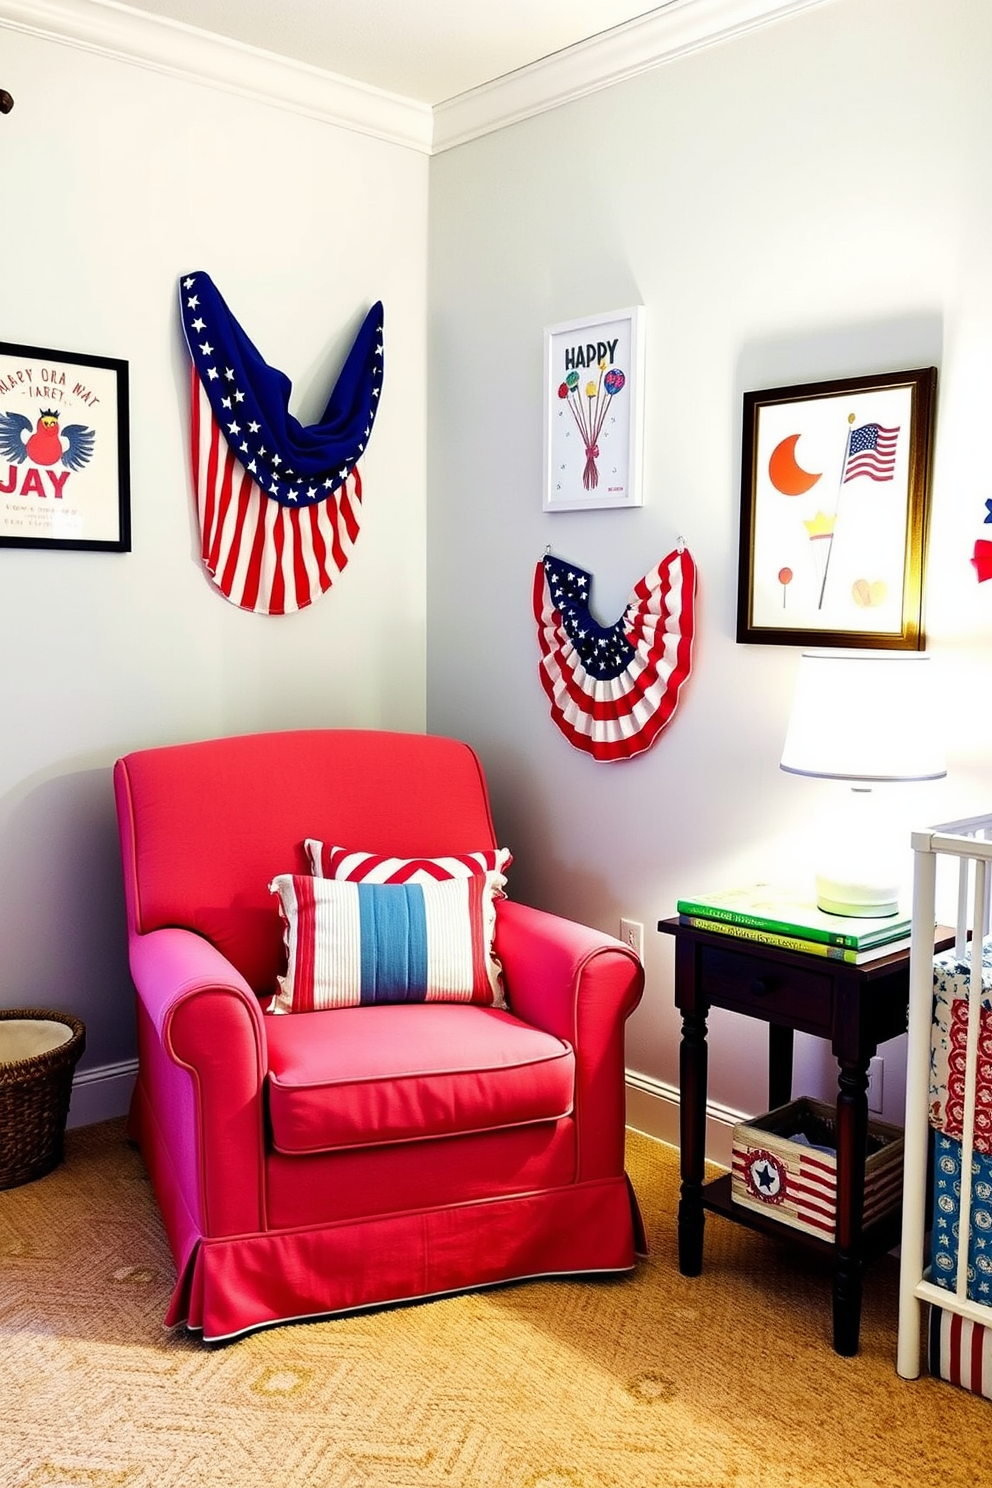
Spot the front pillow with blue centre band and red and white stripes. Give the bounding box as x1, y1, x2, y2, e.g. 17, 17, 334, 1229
268, 873, 506, 1013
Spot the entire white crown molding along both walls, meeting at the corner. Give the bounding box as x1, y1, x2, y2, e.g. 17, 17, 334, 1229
0, 0, 831, 155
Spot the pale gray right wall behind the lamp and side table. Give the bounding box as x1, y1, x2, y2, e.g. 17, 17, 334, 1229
428, 0, 992, 1115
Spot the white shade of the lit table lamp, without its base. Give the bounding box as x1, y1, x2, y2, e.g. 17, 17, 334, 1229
781, 650, 947, 781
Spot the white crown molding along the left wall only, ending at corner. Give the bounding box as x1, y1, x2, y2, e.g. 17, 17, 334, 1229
0, 0, 433, 153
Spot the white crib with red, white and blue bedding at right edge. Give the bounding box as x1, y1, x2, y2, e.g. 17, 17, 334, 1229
897, 815, 992, 1399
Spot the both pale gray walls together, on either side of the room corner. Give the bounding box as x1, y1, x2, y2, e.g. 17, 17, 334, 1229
7, 0, 992, 1130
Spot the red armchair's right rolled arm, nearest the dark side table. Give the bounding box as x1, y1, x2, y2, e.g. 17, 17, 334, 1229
494, 899, 644, 1178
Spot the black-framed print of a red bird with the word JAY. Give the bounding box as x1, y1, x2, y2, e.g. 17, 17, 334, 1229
0, 341, 131, 554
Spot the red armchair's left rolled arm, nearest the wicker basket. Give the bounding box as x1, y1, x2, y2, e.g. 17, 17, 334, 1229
129, 927, 268, 1235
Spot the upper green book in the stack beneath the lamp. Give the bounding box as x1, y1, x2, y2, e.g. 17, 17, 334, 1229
675, 884, 912, 951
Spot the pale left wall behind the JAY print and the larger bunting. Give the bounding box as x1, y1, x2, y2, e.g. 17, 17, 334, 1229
0, 28, 427, 1073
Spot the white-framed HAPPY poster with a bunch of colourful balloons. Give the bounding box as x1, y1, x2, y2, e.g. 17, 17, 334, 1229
544, 305, 644, 512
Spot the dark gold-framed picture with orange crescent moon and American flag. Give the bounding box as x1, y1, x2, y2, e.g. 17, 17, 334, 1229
738, 368, 937, 650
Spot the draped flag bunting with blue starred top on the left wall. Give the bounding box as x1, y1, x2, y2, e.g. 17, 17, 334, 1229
180, 272, 382, 615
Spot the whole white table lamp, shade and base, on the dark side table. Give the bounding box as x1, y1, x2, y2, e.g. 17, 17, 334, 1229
781, 650, 947, 918
